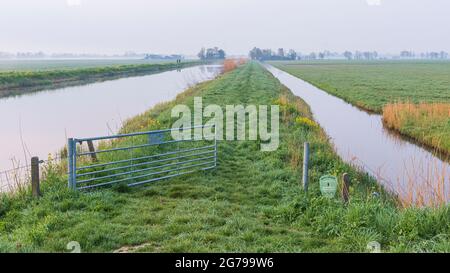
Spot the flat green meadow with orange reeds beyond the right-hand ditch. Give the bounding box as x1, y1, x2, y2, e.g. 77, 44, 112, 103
274, 61, 450, 155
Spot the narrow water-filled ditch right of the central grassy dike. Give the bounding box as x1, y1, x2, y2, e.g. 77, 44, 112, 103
266, 65, 450, 202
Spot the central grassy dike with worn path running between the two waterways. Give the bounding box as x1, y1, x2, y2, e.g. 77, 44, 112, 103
0, 63, 450, 252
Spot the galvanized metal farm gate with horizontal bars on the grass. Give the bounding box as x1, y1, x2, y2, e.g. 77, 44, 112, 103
68, 125, 218, 190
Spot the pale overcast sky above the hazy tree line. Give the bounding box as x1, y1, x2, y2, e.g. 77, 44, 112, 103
0, 0, 450, 54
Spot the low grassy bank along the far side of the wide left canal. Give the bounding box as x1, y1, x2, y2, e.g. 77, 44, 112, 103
0, 61, 201, 98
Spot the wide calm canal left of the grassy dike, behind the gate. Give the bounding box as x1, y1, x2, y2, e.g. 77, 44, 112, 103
0, 65, 221, 172
